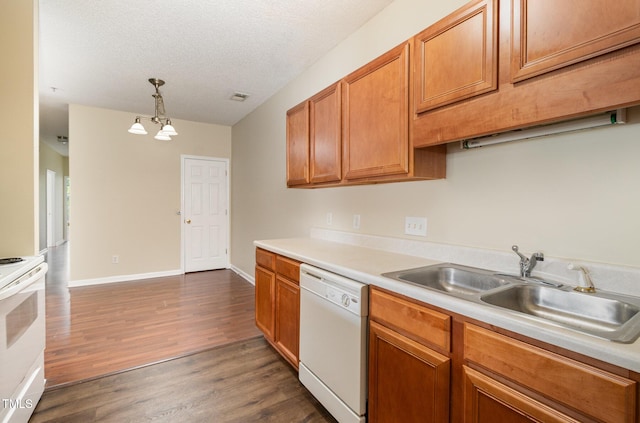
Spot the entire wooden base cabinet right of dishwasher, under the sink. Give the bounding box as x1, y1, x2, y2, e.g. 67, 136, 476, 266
369, 287, 640, 423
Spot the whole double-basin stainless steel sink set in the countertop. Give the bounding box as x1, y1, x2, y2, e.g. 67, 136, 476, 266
382, 263, 640, 343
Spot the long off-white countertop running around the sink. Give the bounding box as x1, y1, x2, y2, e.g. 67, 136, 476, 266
254, 238, 640, 372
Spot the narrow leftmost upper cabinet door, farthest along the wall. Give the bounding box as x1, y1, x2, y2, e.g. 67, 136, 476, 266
287, 101, 309, 186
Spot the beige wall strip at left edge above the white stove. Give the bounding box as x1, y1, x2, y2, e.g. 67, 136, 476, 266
0, 0, 39, 257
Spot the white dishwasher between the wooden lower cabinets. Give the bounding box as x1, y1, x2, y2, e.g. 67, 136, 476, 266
299, 264, 369, 423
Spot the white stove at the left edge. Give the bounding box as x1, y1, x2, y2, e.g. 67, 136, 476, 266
0, 256, 48, 423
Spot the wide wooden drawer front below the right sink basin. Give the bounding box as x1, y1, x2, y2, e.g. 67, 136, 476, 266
464, 323, 637, 422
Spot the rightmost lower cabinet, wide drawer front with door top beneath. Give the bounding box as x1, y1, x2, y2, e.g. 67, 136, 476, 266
463, 323, 638, 422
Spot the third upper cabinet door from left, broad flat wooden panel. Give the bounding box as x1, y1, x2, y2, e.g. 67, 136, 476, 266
342, 42, 411, 179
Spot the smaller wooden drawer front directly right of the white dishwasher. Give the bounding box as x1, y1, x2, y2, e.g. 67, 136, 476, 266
369, 287, 451, 351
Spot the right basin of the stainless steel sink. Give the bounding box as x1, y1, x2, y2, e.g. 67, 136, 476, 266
480, 284, 640, 342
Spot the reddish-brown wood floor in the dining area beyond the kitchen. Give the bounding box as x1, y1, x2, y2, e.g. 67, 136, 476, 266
45, 243, 260, 387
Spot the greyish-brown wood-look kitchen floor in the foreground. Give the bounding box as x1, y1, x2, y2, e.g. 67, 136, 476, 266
30, 337, 335, 423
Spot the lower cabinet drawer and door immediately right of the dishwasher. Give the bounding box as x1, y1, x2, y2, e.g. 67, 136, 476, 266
368, 288, 451, 423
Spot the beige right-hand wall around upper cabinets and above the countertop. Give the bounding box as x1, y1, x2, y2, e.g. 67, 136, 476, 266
231, 0, 640, 274
